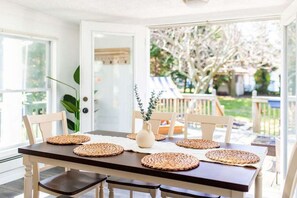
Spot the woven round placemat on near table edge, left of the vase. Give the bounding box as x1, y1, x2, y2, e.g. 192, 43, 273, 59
73, 143, 124, 157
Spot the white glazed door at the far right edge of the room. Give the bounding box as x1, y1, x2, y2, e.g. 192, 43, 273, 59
280, 1, 297, 184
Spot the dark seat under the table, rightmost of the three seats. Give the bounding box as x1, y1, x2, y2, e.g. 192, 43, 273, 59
160, 185, 220, 198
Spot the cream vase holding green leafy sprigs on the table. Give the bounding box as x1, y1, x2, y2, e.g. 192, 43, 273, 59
134, 85, 162, 148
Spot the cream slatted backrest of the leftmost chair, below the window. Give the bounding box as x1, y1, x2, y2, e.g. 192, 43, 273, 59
23, 111, 68, 145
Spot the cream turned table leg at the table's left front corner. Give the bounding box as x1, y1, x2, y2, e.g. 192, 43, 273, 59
23, 155, 32, 198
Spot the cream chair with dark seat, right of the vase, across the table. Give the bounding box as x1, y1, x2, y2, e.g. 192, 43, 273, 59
160, 114, 233, 198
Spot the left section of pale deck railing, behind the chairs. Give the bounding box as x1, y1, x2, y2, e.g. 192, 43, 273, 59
156, 90, 224, 116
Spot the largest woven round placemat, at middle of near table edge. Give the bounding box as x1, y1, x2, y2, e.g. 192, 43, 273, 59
141, 153, 199, 171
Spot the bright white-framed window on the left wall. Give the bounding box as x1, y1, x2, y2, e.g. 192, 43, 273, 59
0, 34, 51, 151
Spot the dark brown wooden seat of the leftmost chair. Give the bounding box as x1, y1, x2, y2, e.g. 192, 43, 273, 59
39, 170, 107, 195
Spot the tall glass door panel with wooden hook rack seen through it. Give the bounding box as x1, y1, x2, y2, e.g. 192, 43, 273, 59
93, 33, 133, 132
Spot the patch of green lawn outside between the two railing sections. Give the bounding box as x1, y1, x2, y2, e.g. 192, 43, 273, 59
218, 96, 252, 121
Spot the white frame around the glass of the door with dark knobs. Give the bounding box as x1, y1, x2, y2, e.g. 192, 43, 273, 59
80, 21, 150, 132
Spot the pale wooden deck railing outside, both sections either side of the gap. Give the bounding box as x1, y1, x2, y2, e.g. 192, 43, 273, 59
156, 90, 280, 136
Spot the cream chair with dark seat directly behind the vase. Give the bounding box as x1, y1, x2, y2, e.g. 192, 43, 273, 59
106, 111, 176, 198
